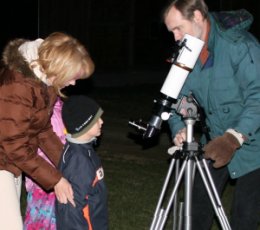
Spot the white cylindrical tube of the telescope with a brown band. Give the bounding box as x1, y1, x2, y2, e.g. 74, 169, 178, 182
160, 34, 204, 99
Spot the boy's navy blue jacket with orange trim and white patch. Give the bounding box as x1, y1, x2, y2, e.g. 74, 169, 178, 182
56, 141, 108, 230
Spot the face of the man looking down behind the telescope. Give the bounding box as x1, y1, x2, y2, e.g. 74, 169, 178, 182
164, 7, 203, 41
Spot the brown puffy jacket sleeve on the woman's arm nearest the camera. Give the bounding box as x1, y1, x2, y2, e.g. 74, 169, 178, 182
0, 82, 61, 190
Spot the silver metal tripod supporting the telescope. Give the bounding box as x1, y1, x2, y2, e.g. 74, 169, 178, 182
150, 116, 231, 230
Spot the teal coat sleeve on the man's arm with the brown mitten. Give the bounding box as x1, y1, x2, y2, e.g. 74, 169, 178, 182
231, 38, 260, 141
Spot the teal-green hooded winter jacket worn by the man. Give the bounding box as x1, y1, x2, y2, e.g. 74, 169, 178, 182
168, 10, 260, 178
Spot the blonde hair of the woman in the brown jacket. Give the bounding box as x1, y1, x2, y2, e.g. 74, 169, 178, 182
37, 32, 95, 96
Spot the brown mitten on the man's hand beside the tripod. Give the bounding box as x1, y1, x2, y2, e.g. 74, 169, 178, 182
203, 132, 240, 168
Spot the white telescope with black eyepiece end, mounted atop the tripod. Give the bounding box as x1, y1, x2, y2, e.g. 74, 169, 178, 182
129, 34, 204, 139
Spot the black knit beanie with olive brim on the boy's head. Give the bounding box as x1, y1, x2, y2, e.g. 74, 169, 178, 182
62, 95, 103, 138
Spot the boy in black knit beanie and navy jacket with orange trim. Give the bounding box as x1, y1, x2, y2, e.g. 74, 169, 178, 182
56, 95, 108, 230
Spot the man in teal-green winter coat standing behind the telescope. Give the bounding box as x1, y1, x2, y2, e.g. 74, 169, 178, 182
164, 0, 260, 230
